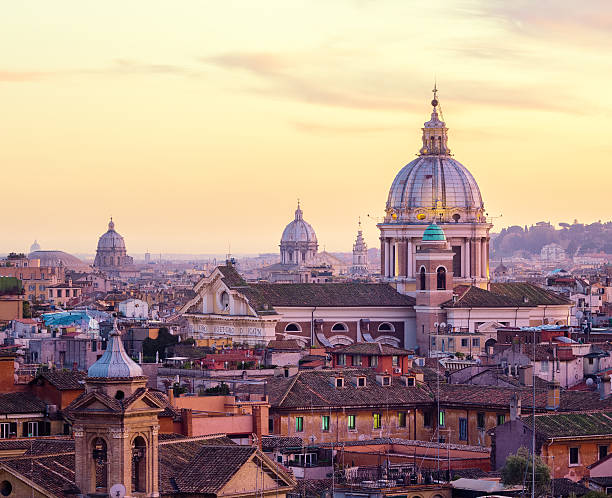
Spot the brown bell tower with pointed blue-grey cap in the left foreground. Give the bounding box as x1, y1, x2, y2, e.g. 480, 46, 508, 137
71, 321, 163, 497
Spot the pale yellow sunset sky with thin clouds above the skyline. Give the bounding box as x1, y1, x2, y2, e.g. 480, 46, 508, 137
0, 0, 612, 254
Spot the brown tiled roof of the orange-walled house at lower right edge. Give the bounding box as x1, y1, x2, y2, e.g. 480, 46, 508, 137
523, 411, 612, 438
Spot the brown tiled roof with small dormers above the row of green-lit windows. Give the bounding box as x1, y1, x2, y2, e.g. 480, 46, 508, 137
267, 368, 433, 409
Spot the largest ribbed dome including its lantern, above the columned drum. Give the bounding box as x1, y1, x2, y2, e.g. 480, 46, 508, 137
385, 91, 485, 223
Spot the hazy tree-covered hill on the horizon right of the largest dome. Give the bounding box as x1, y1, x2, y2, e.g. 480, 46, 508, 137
491, 221, 612, 258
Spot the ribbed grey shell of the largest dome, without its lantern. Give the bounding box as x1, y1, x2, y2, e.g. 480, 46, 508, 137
387, 155, 484, 213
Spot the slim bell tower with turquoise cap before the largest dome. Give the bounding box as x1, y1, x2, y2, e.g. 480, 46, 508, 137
414, 221, 453, 355
